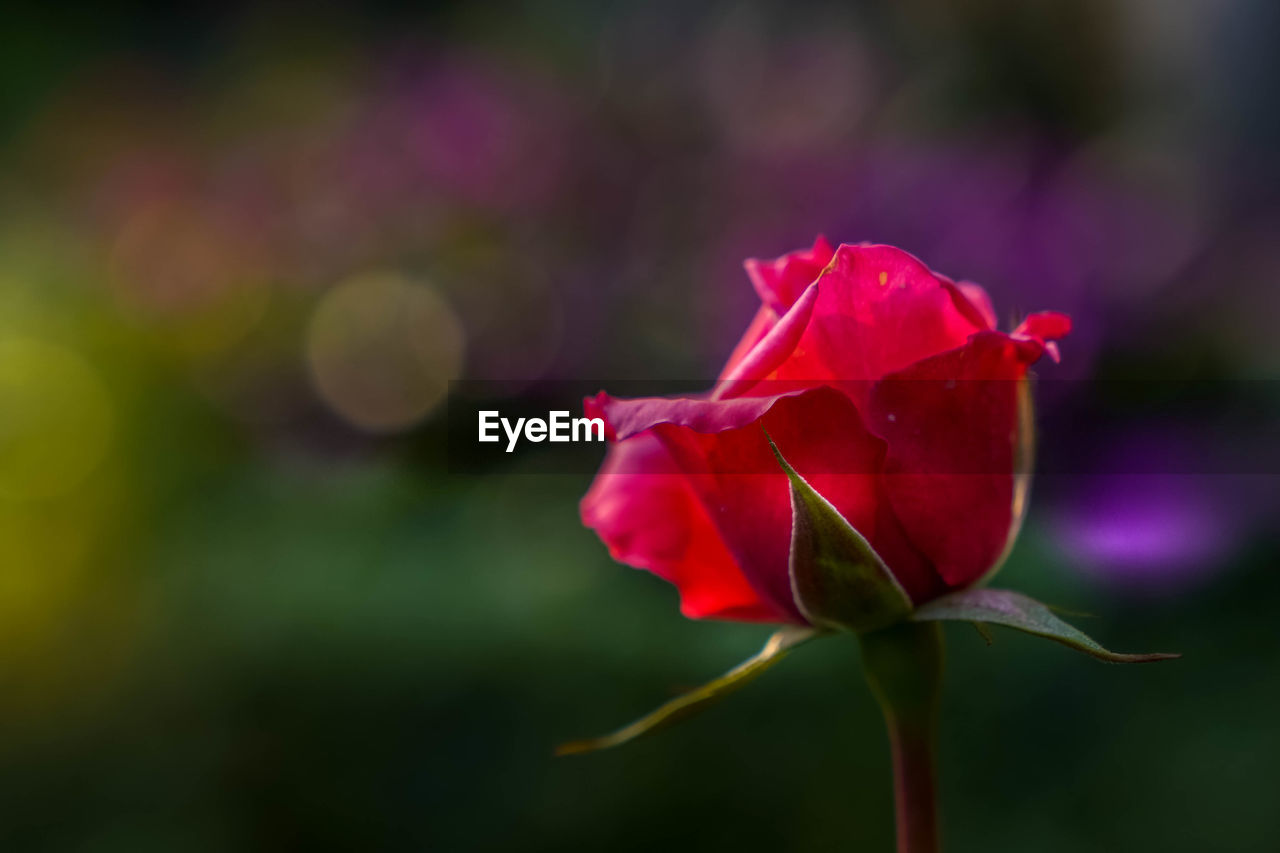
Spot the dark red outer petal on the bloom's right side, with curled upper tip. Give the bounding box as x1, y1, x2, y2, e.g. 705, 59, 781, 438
868, 326, 1064, 587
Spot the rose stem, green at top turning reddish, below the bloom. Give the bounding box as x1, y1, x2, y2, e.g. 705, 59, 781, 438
861, 622, 942, 853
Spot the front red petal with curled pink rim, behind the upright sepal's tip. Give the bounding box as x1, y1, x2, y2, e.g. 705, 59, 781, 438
595, 387, 942, 612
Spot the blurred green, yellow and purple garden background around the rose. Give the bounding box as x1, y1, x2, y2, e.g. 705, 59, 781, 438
0, 0, 1280, 852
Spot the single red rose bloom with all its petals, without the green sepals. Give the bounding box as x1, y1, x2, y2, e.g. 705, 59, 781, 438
581, 238, 1070, 624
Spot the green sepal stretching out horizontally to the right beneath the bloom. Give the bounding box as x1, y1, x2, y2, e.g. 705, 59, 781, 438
911, 589, 1181, 663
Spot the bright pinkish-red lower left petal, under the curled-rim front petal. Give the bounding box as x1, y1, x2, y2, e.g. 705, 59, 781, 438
580, 434, 785, 622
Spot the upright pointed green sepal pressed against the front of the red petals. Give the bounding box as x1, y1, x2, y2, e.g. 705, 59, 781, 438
765, 434, 911, 634
